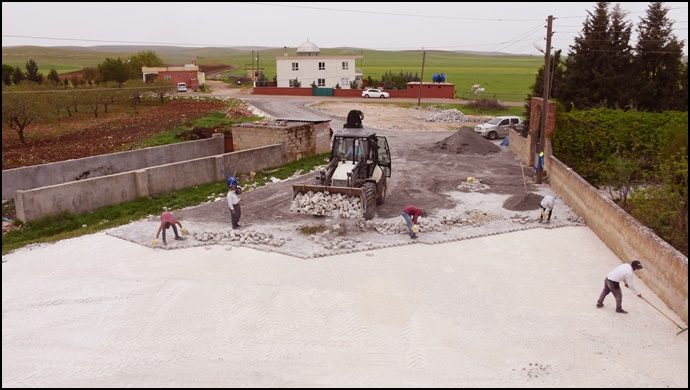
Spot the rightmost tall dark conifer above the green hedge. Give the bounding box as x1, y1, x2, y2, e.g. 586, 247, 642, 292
634, 2, 687, 112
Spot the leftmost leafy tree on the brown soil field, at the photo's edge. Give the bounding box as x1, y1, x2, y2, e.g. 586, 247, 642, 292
2, 81, 50, 144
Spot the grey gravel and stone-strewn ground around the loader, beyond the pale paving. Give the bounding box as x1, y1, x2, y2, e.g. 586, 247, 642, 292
108, 95, 582, 258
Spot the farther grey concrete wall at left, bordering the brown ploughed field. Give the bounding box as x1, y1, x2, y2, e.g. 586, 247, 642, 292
2, 134, 223, 199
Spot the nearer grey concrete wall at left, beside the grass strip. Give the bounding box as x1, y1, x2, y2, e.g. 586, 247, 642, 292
14, 143, 288, 222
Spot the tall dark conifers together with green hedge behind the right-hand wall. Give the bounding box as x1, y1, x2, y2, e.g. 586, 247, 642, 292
525, 2, 688, 256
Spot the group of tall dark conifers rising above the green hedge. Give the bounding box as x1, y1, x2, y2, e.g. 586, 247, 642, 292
526, 2, 688, 112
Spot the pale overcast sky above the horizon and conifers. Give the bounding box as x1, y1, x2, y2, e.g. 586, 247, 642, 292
2, 2, 688, 55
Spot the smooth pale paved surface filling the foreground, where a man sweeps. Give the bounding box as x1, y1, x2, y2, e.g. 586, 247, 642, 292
2, 226, 688, 388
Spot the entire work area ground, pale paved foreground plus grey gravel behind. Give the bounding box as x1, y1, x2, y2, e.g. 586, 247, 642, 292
2, 88, 688, 388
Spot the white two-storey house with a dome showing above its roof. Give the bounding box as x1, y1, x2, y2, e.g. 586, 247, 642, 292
276, 40, 362, 89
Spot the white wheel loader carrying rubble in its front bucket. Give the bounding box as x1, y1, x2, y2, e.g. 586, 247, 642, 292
292, 110, 391, 220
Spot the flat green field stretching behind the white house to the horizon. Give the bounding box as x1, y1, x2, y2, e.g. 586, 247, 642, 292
2, 46, 544, 101
